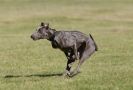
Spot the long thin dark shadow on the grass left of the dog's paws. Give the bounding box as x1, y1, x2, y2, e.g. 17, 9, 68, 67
4, 73, 62, 78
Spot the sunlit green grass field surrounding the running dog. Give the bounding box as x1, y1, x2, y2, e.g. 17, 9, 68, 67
0, 0, 133, 90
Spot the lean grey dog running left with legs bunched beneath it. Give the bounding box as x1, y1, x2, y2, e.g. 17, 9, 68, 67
31, 22, 98, 77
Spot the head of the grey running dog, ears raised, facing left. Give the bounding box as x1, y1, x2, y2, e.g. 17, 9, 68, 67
31, 22, 51, 40
